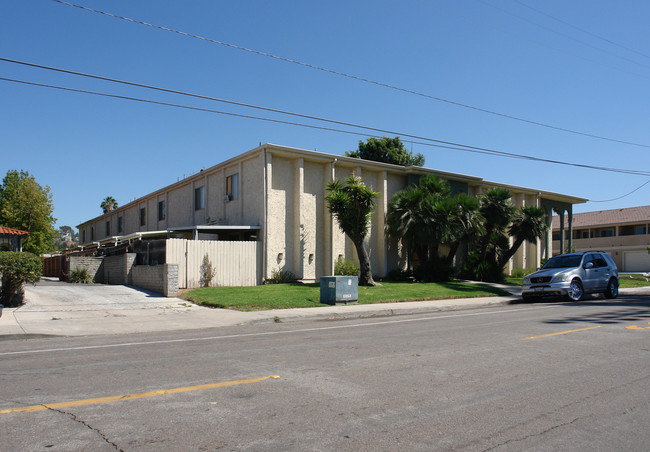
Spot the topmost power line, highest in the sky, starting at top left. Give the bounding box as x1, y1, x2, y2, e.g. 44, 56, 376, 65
52, 0, 650, 152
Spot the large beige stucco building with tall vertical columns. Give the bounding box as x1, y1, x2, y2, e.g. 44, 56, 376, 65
78, 144, 586, 280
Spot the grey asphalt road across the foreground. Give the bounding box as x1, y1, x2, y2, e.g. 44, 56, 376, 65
0, 296, 650, 451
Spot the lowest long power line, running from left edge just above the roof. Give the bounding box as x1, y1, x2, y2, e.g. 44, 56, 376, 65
5, 77, 650, 177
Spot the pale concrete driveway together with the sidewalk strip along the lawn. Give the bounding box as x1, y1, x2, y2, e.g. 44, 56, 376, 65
0, 281, 644, 336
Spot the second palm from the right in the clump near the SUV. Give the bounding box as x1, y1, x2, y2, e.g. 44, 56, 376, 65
479, 188, 515, 262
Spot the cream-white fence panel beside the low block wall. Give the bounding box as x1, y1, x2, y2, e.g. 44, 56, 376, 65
167, 239, 262, 289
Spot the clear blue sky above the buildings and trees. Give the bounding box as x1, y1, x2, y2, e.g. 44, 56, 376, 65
0, 0, 650, 230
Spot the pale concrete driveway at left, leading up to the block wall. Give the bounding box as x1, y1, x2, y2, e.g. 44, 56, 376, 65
0, 278, 260, 336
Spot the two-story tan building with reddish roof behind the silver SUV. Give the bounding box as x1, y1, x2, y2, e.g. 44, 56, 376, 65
553, 206, 650, 272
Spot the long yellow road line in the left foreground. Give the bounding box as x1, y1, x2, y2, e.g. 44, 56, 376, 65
0, 375, 280, 414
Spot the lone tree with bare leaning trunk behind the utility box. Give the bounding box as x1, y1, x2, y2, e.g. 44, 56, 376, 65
325, 177, 377, 286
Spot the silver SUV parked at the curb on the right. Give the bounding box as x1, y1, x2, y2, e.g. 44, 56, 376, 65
521, 251, 618, 301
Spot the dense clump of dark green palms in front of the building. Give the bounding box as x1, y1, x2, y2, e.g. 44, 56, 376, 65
386, 180, 547, 281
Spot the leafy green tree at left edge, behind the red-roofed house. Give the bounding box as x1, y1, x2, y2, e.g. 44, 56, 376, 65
0, 170, 56, 254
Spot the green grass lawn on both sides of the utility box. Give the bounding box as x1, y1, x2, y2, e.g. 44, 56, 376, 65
180, 282, 507, 311
